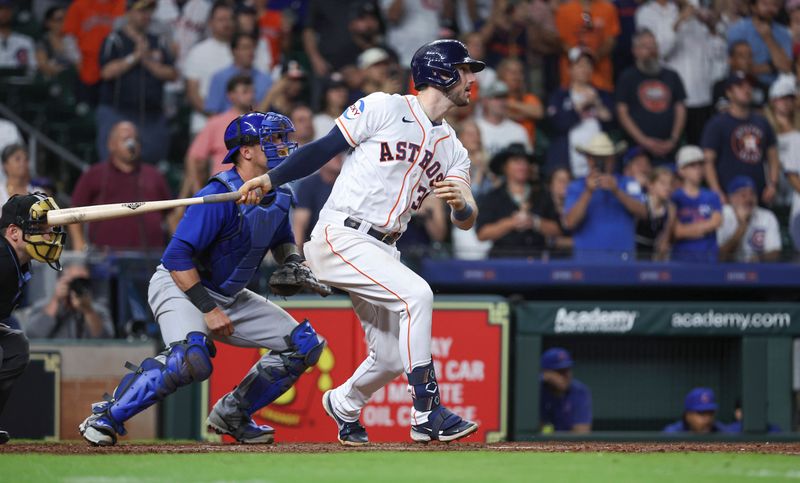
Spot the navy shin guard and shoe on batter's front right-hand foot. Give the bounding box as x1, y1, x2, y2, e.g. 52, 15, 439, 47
406, 362, 478, 443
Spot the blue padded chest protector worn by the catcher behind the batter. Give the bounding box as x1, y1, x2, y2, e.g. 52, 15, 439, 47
207, 169, 292, 296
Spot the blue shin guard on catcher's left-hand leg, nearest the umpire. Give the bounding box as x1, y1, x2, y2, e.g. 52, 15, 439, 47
92, 332, 217, 435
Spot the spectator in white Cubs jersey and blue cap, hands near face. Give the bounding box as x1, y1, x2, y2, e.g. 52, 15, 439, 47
717, 176, 782, 262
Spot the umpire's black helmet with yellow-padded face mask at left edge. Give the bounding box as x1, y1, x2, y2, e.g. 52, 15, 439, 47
0, 192, 67, 270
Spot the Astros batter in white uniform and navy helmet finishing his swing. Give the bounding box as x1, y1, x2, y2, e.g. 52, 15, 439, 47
240, 40, 484, 445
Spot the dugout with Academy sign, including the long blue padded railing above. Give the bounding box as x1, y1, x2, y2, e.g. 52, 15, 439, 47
423, 258, 800, 440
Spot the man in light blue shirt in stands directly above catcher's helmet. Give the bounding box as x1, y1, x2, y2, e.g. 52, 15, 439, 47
206, 33, 272, 113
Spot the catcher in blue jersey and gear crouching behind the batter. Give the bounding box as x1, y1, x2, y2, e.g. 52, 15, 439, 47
79, 112, 330, 446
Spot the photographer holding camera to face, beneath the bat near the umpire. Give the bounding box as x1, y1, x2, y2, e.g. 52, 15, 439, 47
21, 265, 114, 339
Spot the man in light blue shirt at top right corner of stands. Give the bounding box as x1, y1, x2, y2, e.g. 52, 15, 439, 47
728, 0, 792, 85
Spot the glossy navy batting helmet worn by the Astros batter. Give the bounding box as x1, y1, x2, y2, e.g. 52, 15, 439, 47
411, 39, 486, 89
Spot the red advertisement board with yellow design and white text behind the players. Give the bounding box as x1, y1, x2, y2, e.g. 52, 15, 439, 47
202, 299, 509, 442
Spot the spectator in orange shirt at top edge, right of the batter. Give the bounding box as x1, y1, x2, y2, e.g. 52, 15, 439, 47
556, 0, 620, 91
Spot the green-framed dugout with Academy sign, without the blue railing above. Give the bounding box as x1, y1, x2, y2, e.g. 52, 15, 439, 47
512, 302, 800, 439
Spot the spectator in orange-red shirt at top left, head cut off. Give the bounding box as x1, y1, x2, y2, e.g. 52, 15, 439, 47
64, 0, 125, 105
